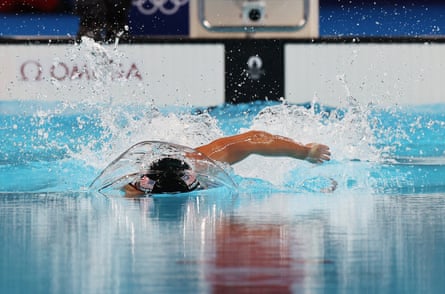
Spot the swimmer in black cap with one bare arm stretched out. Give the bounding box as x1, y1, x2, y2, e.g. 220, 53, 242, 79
124, 131, 331, 197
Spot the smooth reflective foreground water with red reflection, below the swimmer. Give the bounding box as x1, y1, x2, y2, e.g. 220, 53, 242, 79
0, 193, 445, 293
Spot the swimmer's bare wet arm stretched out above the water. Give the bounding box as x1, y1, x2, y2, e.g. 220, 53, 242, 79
196, 131, 331, 164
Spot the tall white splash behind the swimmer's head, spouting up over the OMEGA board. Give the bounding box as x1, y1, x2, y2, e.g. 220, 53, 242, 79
58, 38, 222, 169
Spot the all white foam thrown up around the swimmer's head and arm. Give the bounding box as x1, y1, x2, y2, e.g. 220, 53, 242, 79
58, 40, 388, 192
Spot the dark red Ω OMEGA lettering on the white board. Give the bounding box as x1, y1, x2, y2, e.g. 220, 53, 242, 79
20, 60, 142, 81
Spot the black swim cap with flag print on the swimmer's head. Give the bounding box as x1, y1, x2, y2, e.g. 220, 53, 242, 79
135, 157, 199, 194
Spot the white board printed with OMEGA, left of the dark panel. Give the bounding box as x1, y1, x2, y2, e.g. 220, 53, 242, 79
0, 43, 224, 106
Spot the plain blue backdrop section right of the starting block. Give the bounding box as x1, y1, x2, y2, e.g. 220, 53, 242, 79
320, 0, 445, 37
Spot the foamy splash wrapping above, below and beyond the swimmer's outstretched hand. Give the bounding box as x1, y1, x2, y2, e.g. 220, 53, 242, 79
229, 96, 424, 191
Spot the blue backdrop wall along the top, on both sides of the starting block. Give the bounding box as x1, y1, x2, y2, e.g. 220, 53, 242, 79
0, 0, 445, 38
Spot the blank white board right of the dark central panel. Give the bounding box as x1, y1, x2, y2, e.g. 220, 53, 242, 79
285, 43, 445, 106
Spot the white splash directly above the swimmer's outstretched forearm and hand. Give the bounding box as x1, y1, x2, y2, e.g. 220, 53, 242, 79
248, 103, 381, 161
